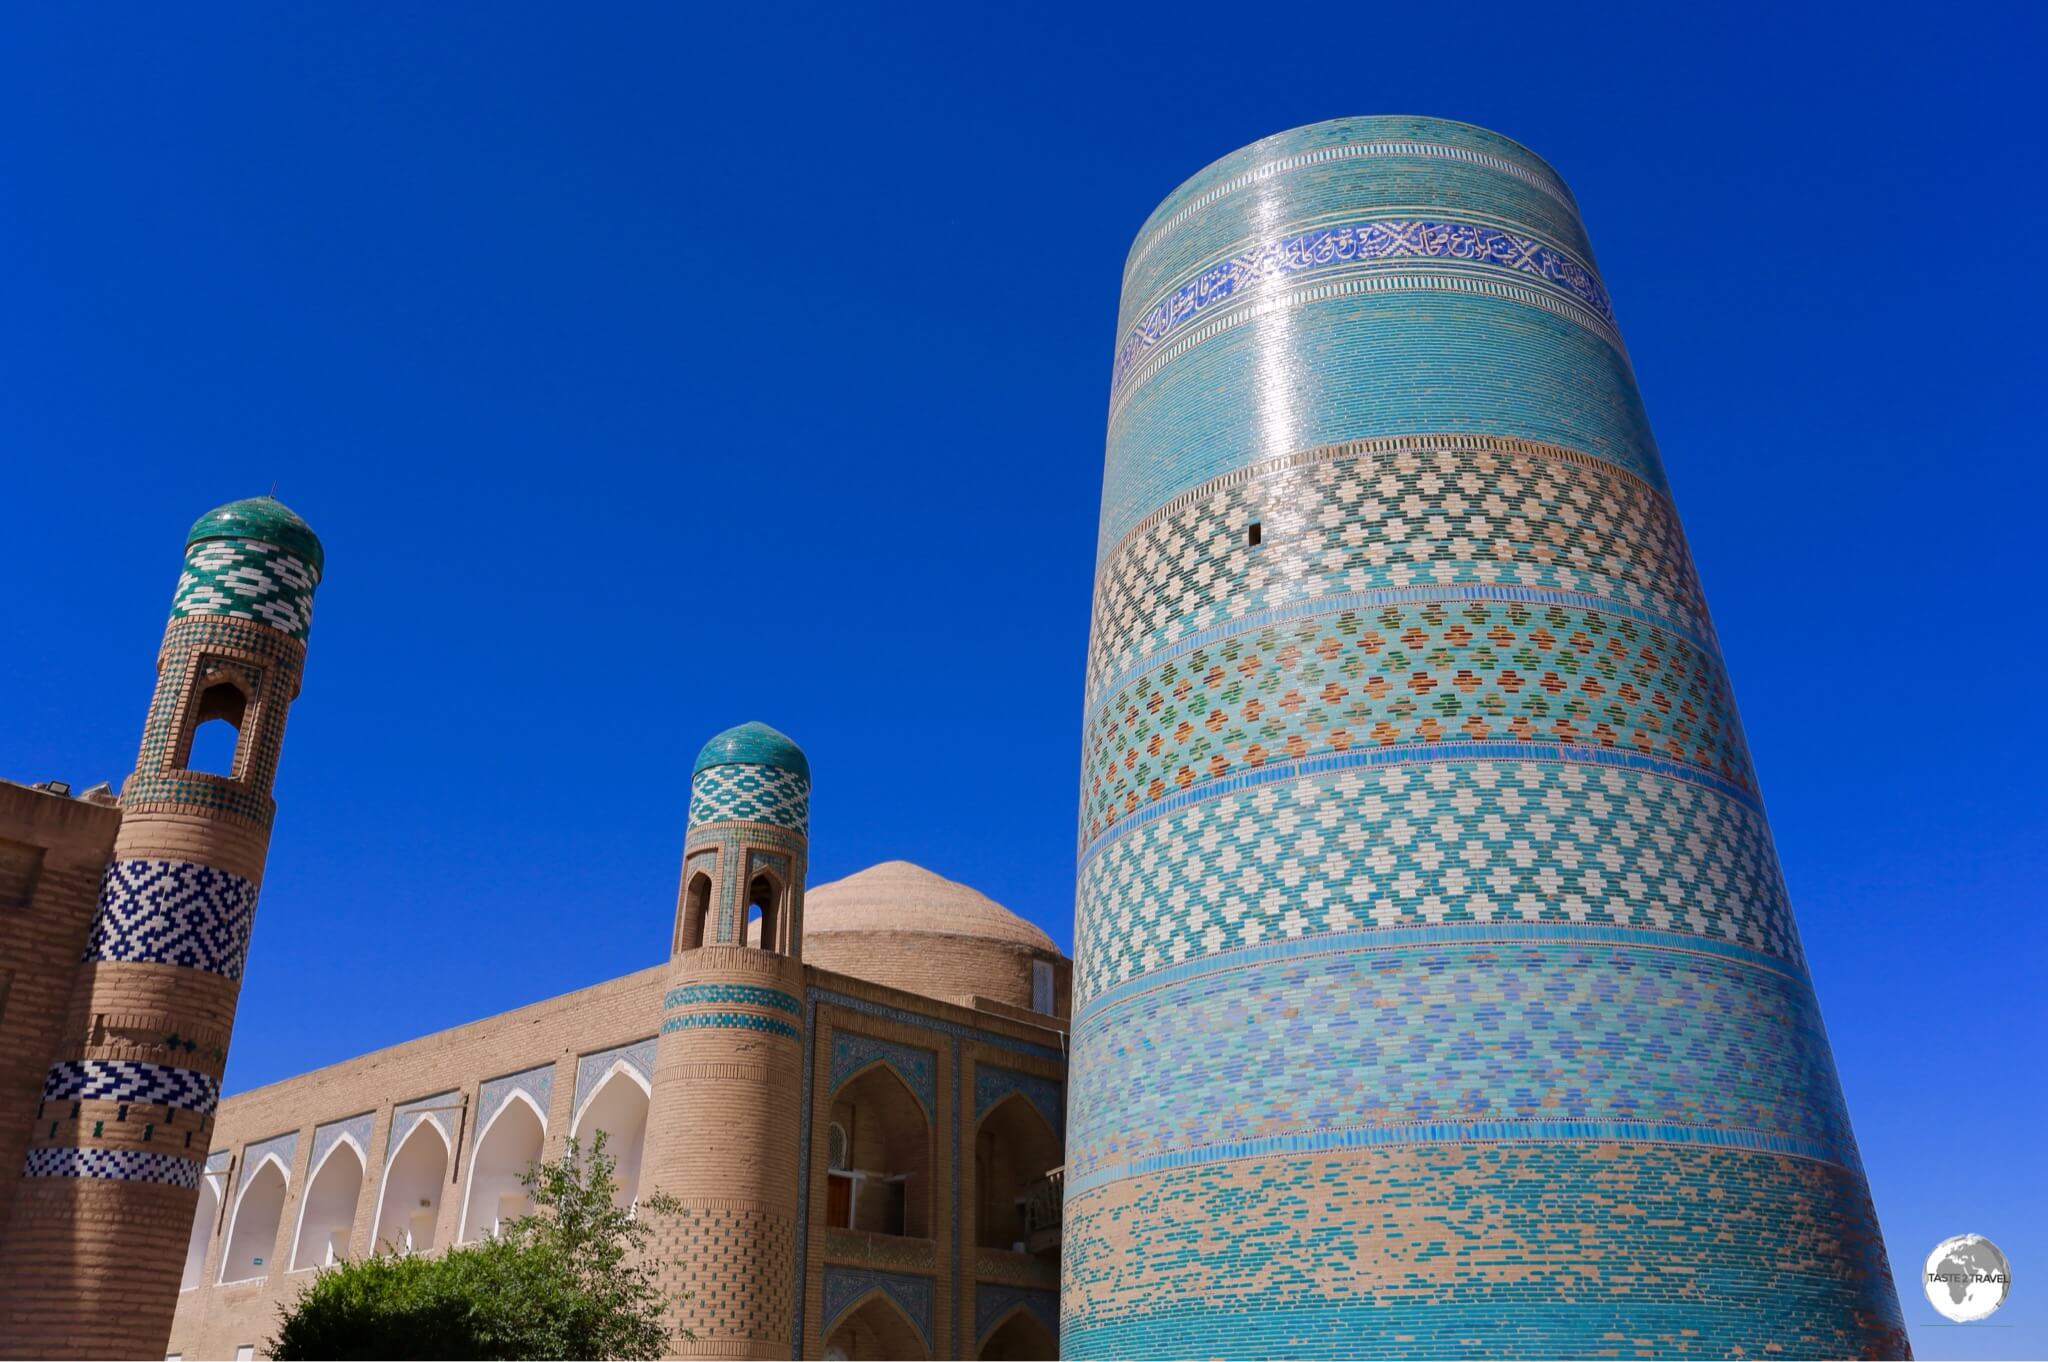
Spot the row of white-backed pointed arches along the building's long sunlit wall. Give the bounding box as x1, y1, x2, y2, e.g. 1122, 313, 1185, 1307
184, 1063, 651, 1290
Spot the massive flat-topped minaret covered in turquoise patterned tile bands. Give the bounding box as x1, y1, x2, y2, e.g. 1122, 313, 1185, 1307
1061, 117, 1905, 1358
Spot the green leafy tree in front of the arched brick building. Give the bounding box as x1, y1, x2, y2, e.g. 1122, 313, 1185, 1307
268, 1131, 688, 1360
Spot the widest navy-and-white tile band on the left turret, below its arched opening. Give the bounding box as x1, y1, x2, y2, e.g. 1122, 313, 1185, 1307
84, 860, 256, 979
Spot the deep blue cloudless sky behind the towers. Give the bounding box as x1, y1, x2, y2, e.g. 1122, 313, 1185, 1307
0, 4, 2048, 1358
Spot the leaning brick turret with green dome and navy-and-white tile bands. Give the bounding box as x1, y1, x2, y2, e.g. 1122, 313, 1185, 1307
0, 498, 322, 1358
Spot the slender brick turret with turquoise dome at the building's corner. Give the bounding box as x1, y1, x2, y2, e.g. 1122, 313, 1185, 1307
641, 723, 811, 1358
